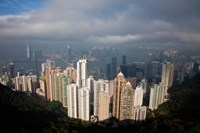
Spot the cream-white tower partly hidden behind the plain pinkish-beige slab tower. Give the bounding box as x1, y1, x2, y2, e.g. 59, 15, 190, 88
94, 79, 109, 116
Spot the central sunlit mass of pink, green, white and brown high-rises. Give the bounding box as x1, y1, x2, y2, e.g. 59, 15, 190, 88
40, 59, 147, 121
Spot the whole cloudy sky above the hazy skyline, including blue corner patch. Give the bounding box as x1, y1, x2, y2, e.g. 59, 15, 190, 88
0, 0, 200, 45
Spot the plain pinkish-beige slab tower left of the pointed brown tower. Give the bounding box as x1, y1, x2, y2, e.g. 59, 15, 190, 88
98, 91, 110, 121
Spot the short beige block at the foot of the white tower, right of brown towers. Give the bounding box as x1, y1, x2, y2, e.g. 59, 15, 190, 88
134, 106, 147, 121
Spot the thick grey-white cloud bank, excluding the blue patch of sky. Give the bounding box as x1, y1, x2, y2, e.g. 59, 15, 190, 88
0, 0, 200, 44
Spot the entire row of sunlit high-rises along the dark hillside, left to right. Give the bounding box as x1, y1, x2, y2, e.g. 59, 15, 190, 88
1, 59, 174, 121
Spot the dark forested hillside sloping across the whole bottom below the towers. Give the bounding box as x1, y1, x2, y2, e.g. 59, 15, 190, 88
0, 74, 200, 133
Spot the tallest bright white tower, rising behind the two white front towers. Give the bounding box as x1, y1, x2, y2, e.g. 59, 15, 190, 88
76, 59, 87, 88
